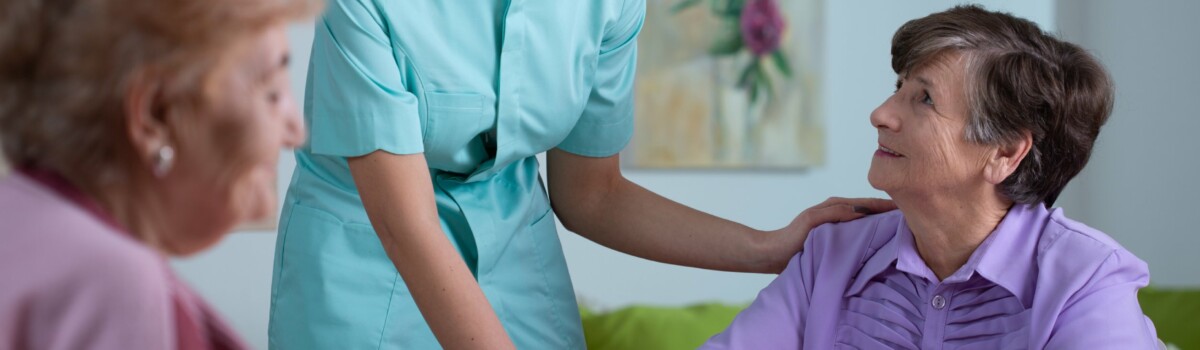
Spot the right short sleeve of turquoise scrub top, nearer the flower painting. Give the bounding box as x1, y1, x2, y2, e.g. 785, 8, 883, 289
558, 0, 646, 157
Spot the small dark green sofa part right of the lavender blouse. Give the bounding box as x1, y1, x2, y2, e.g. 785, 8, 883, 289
1138, 288, 1200, 349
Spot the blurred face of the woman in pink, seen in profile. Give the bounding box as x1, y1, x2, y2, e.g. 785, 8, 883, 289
163, 24, 306, 254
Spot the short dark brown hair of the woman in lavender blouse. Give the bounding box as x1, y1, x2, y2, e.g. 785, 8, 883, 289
892, 5, 1114, 205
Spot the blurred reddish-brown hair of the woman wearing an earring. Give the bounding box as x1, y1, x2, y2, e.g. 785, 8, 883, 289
0, 0, 322, 188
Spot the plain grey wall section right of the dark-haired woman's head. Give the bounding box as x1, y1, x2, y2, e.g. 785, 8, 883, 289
1058, 0, 1200, 286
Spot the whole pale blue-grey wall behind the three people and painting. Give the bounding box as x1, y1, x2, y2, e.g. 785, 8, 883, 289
174, 0, 1200, 348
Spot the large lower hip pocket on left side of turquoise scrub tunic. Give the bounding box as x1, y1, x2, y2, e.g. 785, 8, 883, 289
269, 204, 400, 349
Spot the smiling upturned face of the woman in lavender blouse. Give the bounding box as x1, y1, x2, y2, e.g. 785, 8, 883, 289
868, 53, 989, 198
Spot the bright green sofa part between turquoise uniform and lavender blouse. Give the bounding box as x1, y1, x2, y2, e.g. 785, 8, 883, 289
580, 303, 746, 350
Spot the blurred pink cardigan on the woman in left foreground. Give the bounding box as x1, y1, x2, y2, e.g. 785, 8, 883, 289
0, 171, 246, 350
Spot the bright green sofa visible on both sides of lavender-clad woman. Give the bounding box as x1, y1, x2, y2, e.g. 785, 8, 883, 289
580, 288, 1200, 350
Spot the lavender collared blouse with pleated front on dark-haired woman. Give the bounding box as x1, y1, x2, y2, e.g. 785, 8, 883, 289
701, 205, 1158, 349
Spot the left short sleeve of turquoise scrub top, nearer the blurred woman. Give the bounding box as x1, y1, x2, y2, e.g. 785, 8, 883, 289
306, 0, 424, 157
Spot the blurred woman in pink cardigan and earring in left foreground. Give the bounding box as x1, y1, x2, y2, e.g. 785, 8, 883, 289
0, 0, 318, 349
